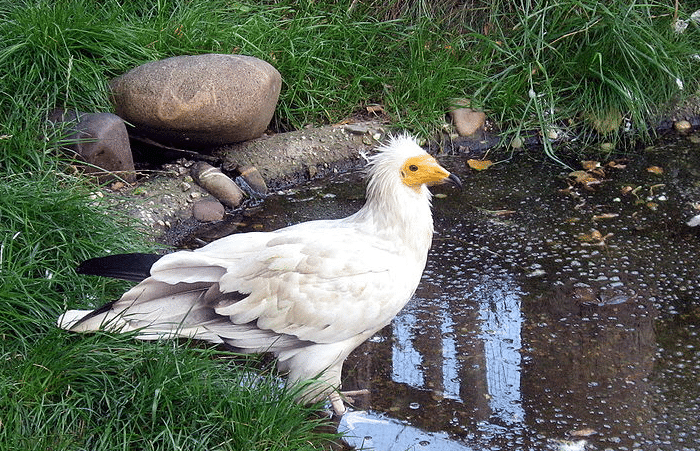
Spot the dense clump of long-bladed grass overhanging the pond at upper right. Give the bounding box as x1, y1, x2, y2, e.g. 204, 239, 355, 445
463, 0, 700, 152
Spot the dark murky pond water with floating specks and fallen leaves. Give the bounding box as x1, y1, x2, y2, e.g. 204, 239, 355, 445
239, 139, 700, 450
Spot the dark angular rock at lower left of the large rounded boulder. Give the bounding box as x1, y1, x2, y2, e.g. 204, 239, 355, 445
49, 110, 136, 183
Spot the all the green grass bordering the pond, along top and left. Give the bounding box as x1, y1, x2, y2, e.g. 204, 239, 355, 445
0, 0, 700, 450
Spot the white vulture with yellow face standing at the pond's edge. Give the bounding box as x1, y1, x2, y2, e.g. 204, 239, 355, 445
58, 136, 461, 415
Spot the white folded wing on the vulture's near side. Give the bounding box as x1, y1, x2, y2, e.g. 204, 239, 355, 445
146, 228, 416, 343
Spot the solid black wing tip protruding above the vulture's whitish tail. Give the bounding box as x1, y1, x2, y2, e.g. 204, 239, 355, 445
75, 252, 162, 282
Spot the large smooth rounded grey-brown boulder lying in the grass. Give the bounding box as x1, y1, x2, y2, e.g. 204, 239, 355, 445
110, 54, 282, 148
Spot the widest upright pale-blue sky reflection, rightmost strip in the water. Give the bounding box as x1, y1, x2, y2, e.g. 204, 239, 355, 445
474, 280, 524, 423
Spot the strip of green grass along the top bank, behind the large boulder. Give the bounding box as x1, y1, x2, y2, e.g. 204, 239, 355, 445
0, 0, 700, 148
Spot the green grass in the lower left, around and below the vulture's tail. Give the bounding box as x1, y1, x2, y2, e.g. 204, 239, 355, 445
0, 154, 340, 450
